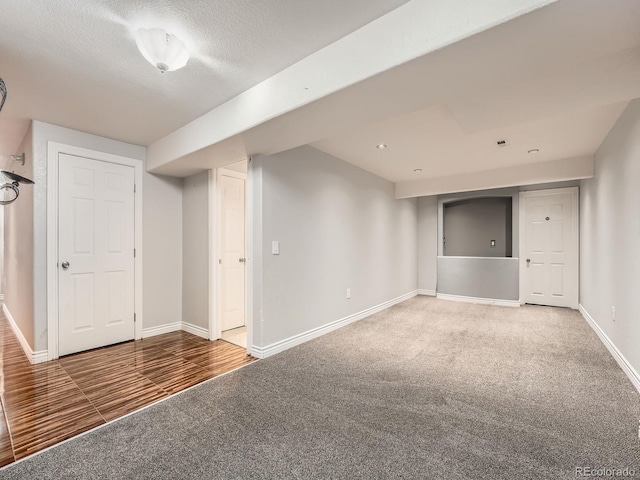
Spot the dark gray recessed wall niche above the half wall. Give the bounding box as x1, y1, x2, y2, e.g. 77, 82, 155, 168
442, 196, 513, 257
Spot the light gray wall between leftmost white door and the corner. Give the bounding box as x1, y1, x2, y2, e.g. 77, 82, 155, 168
142, 173, 182, 328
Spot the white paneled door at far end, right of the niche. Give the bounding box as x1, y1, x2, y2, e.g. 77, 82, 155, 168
521, 188, 578, 308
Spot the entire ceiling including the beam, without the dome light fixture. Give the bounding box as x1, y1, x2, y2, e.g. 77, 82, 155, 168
0, 0, 640, 195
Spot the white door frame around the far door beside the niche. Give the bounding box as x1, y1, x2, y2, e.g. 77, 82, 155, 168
518, 187, 580, 310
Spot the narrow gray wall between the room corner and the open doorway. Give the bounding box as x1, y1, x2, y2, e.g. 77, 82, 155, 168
182, 171, 209, 329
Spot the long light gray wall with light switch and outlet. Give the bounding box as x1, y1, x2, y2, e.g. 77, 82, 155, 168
250, 147, 418, 347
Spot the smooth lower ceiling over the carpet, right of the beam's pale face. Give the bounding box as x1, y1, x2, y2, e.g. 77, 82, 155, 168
145, 0, 640, 189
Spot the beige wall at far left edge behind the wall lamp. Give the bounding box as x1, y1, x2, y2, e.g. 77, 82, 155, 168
0, 122, 34, 349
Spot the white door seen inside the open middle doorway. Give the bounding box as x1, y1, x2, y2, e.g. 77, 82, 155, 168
219, 170, 246, 331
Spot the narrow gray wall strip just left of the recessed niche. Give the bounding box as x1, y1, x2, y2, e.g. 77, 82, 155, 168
418, 196, 438, 292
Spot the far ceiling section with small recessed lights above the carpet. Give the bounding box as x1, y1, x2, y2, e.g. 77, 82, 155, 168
312, 102, 627, 183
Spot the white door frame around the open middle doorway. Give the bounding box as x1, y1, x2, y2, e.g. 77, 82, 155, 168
209, 164, 253, 355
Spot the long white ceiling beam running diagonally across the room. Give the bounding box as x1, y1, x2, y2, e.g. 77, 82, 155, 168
147, 0, 557, 172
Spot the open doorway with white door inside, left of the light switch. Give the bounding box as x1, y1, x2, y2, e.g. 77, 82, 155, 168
216, 161, 247, 348
